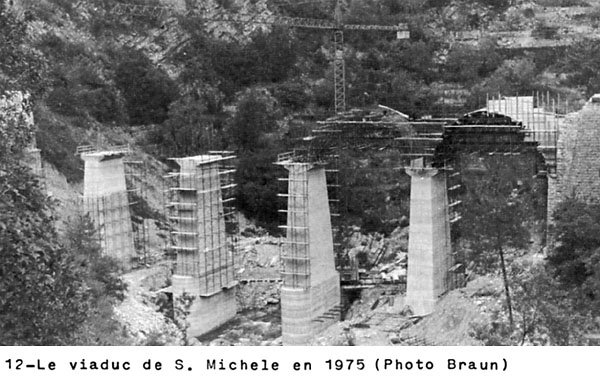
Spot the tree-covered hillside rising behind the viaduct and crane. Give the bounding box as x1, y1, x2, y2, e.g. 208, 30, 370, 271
7, 0, 598, 227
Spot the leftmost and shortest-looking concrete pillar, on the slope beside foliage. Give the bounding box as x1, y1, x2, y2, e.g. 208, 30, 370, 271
81, 151, 135, 268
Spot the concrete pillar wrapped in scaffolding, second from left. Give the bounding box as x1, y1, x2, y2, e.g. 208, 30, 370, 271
171, 155, 236, 336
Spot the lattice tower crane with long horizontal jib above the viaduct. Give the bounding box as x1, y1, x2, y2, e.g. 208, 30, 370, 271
112, 0, 409, 113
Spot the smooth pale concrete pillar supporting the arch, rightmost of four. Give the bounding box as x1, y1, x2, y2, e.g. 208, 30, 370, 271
406, 167, 451, 315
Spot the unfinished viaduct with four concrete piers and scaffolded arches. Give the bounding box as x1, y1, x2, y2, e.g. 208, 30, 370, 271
62, 95, 600, 345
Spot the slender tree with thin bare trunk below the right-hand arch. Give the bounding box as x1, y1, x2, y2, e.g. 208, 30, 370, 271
460, 155, 535, 326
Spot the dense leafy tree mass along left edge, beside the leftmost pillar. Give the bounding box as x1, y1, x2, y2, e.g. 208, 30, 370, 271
0, 86, 124, 345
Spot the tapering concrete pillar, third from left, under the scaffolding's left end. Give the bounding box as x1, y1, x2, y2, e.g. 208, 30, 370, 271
281, 162, 340, 345
